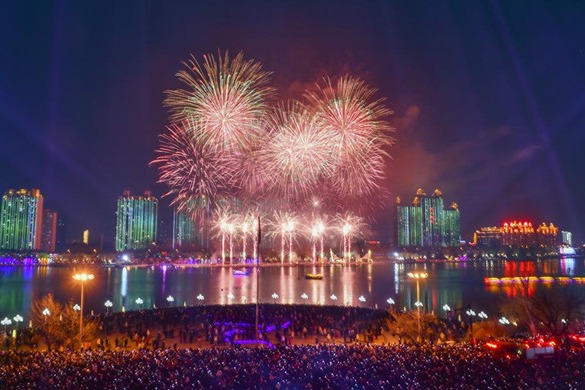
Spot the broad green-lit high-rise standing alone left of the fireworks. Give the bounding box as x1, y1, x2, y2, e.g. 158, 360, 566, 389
115, 191, 158, 251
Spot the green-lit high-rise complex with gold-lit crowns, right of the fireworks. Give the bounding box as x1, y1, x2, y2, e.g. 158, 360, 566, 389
396, 189, 461, 247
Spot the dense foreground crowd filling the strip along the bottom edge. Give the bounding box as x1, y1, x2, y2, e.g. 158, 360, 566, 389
0, 343, 585, 389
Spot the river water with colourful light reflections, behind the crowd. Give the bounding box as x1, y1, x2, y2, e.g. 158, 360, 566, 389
0, 258, 585, 321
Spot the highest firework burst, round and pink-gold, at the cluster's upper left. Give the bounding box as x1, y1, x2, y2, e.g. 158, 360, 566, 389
164, 52, 273, 151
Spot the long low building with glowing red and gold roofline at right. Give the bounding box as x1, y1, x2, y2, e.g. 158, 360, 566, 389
473, 221, 559, 248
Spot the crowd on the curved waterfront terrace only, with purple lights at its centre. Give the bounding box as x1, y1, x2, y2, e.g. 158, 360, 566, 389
100, 305, 389, 348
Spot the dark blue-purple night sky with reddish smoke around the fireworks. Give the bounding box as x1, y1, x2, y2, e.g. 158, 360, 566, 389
0, 0, 585, 242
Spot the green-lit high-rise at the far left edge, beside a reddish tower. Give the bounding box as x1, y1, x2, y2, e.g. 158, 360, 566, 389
0, 189, 43, 251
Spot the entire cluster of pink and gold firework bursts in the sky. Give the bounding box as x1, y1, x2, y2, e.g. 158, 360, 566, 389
152, 53, 392, 251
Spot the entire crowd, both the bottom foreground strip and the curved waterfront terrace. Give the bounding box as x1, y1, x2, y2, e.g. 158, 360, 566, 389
0, 305, 585, 389
